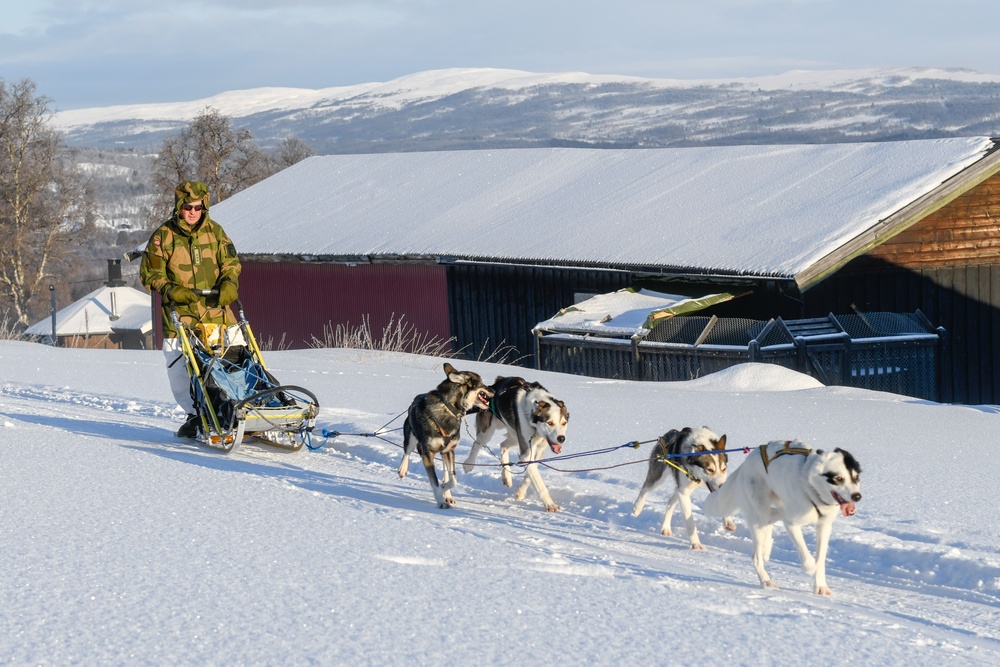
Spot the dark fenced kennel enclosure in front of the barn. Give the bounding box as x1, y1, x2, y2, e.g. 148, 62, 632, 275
537, 311, 940, 400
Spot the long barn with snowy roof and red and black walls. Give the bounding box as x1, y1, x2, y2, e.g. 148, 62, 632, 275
203, 137, 1000, 404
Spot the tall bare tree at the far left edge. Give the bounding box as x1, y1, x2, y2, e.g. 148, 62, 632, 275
0, 79, 92, 326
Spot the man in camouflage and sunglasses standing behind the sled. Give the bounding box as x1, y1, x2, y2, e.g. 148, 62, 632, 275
139, 181, 242, 438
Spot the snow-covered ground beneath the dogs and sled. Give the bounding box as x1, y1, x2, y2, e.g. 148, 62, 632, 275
0, 342, 1000, 665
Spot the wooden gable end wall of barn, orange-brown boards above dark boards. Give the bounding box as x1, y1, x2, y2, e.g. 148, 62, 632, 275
804, 175, 1000, 405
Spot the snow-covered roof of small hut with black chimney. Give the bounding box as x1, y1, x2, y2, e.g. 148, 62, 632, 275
26, 285, 153, 336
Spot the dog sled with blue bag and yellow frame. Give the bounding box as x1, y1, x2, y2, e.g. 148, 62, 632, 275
169, 290, 319, 453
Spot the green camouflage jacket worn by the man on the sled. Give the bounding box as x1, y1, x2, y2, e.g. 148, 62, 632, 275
139, 183, 242, 338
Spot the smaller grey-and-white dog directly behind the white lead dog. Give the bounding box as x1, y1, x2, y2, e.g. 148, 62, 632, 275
632, 426, 736, 549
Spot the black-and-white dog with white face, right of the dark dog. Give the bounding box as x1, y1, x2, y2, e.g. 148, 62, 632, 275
463, 377, 569, 512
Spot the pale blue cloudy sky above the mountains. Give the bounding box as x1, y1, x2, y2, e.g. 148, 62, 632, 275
0, 0, 1000, 111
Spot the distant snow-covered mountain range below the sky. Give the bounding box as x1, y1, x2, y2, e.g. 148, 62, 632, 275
54, 68, 1000, 154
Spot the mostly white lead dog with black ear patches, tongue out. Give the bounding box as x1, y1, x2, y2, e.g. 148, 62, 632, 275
702, 440, 861, 595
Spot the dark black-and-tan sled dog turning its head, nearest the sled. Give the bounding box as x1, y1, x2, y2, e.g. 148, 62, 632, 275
399, 363, 493, 509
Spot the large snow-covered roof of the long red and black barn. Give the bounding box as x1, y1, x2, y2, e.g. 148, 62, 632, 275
212, 137, 993, 286
